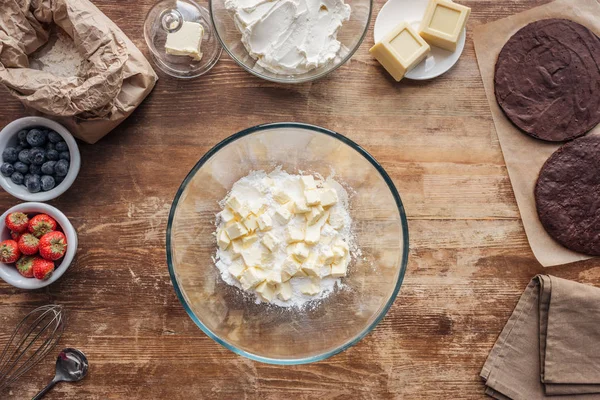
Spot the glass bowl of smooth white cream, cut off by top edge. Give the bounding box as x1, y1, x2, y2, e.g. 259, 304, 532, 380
209, 0, 373, 83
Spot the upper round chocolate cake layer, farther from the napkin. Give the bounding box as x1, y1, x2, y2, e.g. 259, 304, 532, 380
494, 19, 600, 142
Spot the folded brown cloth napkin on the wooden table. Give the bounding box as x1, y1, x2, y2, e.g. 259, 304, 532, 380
481, 275, 600, 400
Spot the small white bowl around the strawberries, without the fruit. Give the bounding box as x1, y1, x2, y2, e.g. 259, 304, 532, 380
0, 203, 77, 289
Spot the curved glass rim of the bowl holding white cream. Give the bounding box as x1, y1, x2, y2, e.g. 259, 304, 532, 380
208, 0, 373, 84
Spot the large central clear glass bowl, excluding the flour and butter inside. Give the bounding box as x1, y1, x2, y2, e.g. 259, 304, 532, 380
167, 123, 408, 364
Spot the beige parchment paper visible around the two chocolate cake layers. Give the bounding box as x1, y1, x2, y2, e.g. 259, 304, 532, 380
473, 0, 600, 267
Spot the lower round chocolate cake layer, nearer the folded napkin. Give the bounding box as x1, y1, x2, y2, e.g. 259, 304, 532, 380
535, 135, 600, 255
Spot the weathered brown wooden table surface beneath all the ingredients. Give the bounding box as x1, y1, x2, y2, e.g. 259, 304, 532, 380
0, 0, 600, 400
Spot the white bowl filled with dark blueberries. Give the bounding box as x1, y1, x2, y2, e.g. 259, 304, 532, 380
0, 117, 81, 201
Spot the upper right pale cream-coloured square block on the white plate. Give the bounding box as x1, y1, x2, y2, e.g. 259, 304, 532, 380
419, 0, 471, 51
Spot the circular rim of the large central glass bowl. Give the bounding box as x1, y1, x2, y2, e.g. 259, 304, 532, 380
166, 122, 409, 365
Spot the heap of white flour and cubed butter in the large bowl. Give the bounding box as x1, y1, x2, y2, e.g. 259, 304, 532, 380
215, 168, 356, 308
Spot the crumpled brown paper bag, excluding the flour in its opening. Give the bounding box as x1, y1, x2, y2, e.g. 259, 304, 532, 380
0, 0, 158, 143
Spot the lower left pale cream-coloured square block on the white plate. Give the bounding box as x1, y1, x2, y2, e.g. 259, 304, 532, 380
369, 21, 431, 81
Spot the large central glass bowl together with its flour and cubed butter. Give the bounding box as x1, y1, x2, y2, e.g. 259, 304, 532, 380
167, 123, 409, 364
